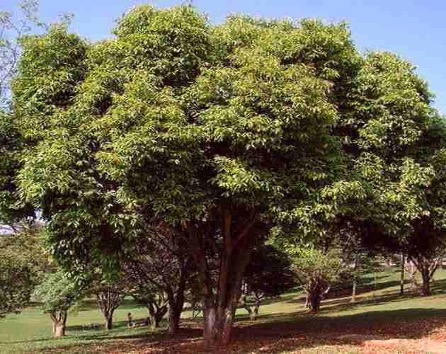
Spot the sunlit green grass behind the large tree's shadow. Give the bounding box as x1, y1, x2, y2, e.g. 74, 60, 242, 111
0, 268, 446, 353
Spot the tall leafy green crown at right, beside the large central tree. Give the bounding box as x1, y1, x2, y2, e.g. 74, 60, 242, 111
322, 52, 446, 302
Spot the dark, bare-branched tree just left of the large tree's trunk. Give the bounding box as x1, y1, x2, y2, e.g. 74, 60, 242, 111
124, 227, 193, 334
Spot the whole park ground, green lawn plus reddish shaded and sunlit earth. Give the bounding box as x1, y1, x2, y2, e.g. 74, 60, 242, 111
0, 268, 446, 353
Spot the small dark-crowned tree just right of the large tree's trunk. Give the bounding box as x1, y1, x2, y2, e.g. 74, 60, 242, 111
242, 245, 296, 320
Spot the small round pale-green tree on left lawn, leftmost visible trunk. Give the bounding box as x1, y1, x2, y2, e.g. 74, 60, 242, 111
33, 271, 82, 337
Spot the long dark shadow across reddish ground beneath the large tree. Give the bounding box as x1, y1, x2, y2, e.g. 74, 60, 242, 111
31, 308, 446, 353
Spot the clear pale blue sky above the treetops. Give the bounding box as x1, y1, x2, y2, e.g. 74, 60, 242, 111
0, 0, 446, 113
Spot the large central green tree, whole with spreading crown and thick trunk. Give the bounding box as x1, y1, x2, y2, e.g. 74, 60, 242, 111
14, 6, 348, 345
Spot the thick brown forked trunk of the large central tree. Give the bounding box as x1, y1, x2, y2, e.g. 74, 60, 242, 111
188, 207, 258, 350
